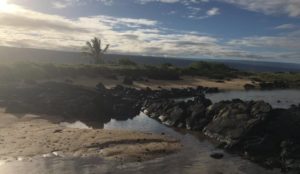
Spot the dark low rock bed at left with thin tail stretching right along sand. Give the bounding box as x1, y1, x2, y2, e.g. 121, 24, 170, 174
0, 82, 218, 127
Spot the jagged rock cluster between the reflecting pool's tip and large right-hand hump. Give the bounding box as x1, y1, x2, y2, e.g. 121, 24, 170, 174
143, 95, 211, 130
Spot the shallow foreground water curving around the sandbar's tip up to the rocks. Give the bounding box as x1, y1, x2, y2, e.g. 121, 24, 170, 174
0, 114, 280, 174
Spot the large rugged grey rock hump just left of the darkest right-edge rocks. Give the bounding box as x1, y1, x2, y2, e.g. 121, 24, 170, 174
203, 100, 272, 147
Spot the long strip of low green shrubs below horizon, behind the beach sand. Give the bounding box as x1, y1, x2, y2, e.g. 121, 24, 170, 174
0, 59, 300, 88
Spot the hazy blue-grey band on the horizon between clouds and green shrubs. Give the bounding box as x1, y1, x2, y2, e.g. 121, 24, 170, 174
0, 47, 300, 72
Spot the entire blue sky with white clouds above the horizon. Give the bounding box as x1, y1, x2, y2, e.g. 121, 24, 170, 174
0, 0, 300, 63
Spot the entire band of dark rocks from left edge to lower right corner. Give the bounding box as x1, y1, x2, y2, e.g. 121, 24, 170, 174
0, 82, 300, 171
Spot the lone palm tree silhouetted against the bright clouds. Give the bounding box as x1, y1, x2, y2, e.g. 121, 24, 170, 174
83, 37, 109, 64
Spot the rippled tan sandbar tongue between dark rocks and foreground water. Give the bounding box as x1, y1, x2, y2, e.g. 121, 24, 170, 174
0, 109, 181, 162
